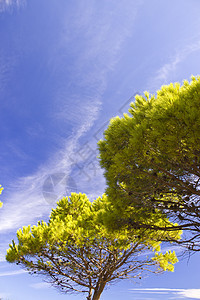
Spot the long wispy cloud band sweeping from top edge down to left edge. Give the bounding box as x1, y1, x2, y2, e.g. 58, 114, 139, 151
0, 1, 141, 240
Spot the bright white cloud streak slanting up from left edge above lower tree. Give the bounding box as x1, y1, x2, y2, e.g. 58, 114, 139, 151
0, 84, 101, 232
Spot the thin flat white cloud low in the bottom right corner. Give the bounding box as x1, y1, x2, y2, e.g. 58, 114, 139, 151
130, 288, 200, 299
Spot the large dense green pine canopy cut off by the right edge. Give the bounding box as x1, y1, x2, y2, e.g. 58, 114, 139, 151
99, 77, 200, 250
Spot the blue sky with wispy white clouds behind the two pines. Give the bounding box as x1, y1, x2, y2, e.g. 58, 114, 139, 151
0, 0, 200, 300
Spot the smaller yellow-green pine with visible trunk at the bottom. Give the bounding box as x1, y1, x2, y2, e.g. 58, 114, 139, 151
6, 193, 177, 300
